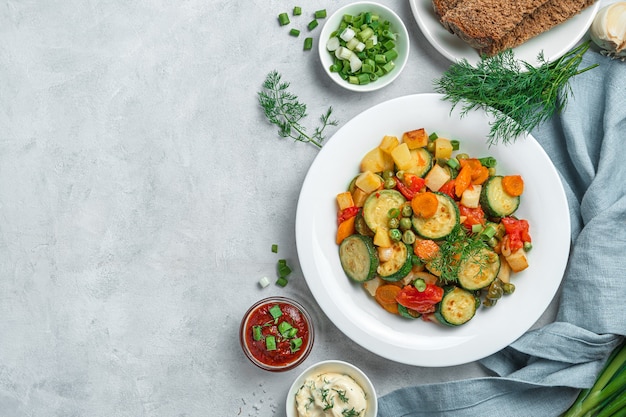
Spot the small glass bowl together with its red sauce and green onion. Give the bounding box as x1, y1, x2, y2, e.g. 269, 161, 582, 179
239, 296, 315, 372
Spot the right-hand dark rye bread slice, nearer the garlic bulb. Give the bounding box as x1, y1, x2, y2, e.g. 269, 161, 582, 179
479, 0, 595, 56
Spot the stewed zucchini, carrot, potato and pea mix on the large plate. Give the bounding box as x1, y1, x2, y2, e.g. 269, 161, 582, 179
336, 128, 532, 326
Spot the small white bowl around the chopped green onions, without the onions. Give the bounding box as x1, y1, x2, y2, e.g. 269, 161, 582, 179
318, 1, 411, 92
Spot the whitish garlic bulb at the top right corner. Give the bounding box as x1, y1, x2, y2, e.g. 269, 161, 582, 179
589, 1, 626, 58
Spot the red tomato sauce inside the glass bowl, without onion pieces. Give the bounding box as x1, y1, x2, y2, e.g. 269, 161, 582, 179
246, 302, 309, 367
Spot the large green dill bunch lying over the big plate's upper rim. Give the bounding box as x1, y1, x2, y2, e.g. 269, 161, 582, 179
434, 41, 598, 145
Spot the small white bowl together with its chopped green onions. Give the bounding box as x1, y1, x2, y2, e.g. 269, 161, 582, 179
319, 1, 410, 92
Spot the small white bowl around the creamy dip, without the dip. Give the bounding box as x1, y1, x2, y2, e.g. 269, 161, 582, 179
287, 360, 378, 417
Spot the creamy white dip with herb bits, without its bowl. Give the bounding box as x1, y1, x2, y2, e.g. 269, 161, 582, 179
296, 372, 367, 417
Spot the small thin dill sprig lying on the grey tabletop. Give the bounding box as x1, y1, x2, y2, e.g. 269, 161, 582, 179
258, 70, 338, 148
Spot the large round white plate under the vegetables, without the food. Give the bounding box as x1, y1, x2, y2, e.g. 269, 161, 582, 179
296, 94, 570, 367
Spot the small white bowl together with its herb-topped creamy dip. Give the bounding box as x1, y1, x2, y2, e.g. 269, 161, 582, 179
287, 360, 378, 417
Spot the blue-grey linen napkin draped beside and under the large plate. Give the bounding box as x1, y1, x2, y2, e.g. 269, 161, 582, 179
378, 50, 626, 417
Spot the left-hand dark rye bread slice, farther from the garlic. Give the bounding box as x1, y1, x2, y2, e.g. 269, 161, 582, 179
441, 0, 548, 50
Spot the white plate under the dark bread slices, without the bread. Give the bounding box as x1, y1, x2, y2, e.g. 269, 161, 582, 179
409, 0, 600, 65
